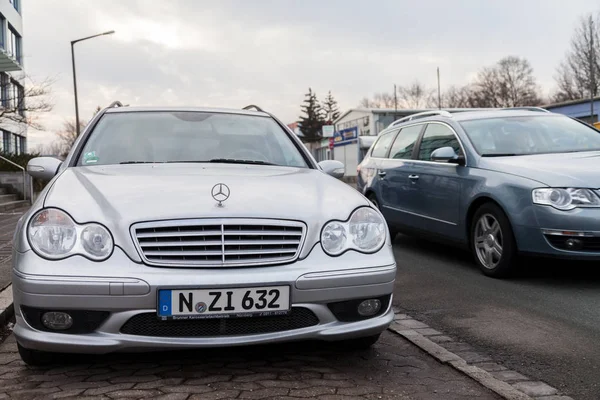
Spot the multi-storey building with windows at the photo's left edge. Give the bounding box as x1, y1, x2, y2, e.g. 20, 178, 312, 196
0, 0, 27, 154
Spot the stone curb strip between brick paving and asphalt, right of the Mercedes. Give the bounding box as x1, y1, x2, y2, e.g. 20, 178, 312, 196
389, 312, 573, 400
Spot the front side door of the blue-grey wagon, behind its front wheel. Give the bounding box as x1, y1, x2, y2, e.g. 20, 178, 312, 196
413, 122, 467, 239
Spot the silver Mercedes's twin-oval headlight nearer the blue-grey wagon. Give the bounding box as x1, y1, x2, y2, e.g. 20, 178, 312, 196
321, 207, 387, 256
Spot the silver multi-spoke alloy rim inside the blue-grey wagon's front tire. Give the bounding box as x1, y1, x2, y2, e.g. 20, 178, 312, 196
474, 214, 504, 269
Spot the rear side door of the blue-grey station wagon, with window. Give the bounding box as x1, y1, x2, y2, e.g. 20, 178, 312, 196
379, 123, 425, 228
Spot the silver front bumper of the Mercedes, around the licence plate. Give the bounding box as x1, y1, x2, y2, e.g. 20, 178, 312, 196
13, 245, 396, 353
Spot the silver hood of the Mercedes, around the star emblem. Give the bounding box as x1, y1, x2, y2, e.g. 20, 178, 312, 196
44, 164, 370, 261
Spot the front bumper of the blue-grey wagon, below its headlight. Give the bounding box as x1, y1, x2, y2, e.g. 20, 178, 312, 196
513, 205, 600, 260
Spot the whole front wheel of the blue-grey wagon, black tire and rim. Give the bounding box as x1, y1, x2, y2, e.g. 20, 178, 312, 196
470, 203, 518, 278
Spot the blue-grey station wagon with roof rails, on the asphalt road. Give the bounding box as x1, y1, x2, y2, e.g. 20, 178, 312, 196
358, 109, 600, 277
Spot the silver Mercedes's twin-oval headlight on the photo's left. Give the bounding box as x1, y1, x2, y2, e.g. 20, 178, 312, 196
27, 208, 114, 261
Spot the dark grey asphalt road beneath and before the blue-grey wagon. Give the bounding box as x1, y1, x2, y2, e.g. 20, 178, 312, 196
394, 235, 600, 399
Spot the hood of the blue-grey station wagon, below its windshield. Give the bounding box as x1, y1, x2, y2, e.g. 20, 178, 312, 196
479, 151, 600, 189
